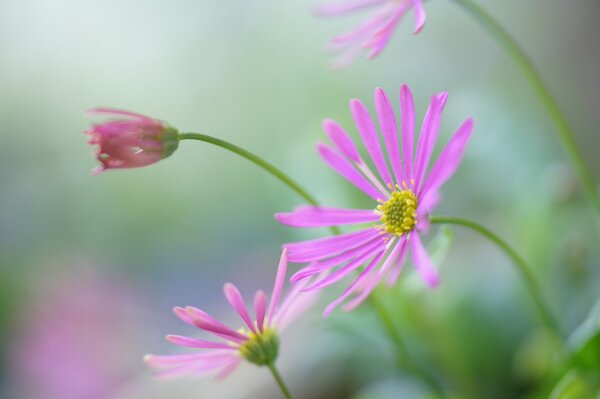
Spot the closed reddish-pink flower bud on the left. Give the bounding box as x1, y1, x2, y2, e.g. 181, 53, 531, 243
85, 108, 178, 174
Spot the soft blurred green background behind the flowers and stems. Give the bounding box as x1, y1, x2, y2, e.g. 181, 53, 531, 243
0, 0, 600, 399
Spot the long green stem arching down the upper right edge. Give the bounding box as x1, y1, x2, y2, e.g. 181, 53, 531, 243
454, 0, 600, 214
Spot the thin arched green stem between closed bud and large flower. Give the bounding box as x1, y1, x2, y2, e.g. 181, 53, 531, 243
179, 133, 339, 234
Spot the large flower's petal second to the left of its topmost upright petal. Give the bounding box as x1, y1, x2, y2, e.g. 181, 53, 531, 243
350, 99, 394, 186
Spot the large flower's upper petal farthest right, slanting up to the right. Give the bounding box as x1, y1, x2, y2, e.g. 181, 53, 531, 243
418, 118, 474, 197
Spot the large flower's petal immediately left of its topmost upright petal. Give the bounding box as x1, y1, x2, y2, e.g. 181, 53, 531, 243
375, 87, 403, 184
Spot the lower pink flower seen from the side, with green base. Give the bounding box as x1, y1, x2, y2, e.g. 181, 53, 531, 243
144, 250, 316, 378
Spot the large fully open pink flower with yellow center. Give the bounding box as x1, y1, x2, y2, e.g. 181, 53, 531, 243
275, 85, 473, 315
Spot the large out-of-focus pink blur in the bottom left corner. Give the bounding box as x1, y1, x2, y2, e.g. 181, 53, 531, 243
9, 265, 143, 399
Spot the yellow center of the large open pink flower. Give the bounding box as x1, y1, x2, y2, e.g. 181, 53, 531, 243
377, 186, 417, 236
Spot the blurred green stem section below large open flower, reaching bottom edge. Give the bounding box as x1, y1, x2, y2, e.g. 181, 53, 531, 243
369, 293, 444, 398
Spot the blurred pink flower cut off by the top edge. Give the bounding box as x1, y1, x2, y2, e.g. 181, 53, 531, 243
315, 0, 425, 68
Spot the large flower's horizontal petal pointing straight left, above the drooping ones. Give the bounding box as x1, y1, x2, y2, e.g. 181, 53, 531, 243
275, 205, 381, 227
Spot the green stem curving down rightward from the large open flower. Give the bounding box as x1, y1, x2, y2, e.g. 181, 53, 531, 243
429, 216, 564, 342
